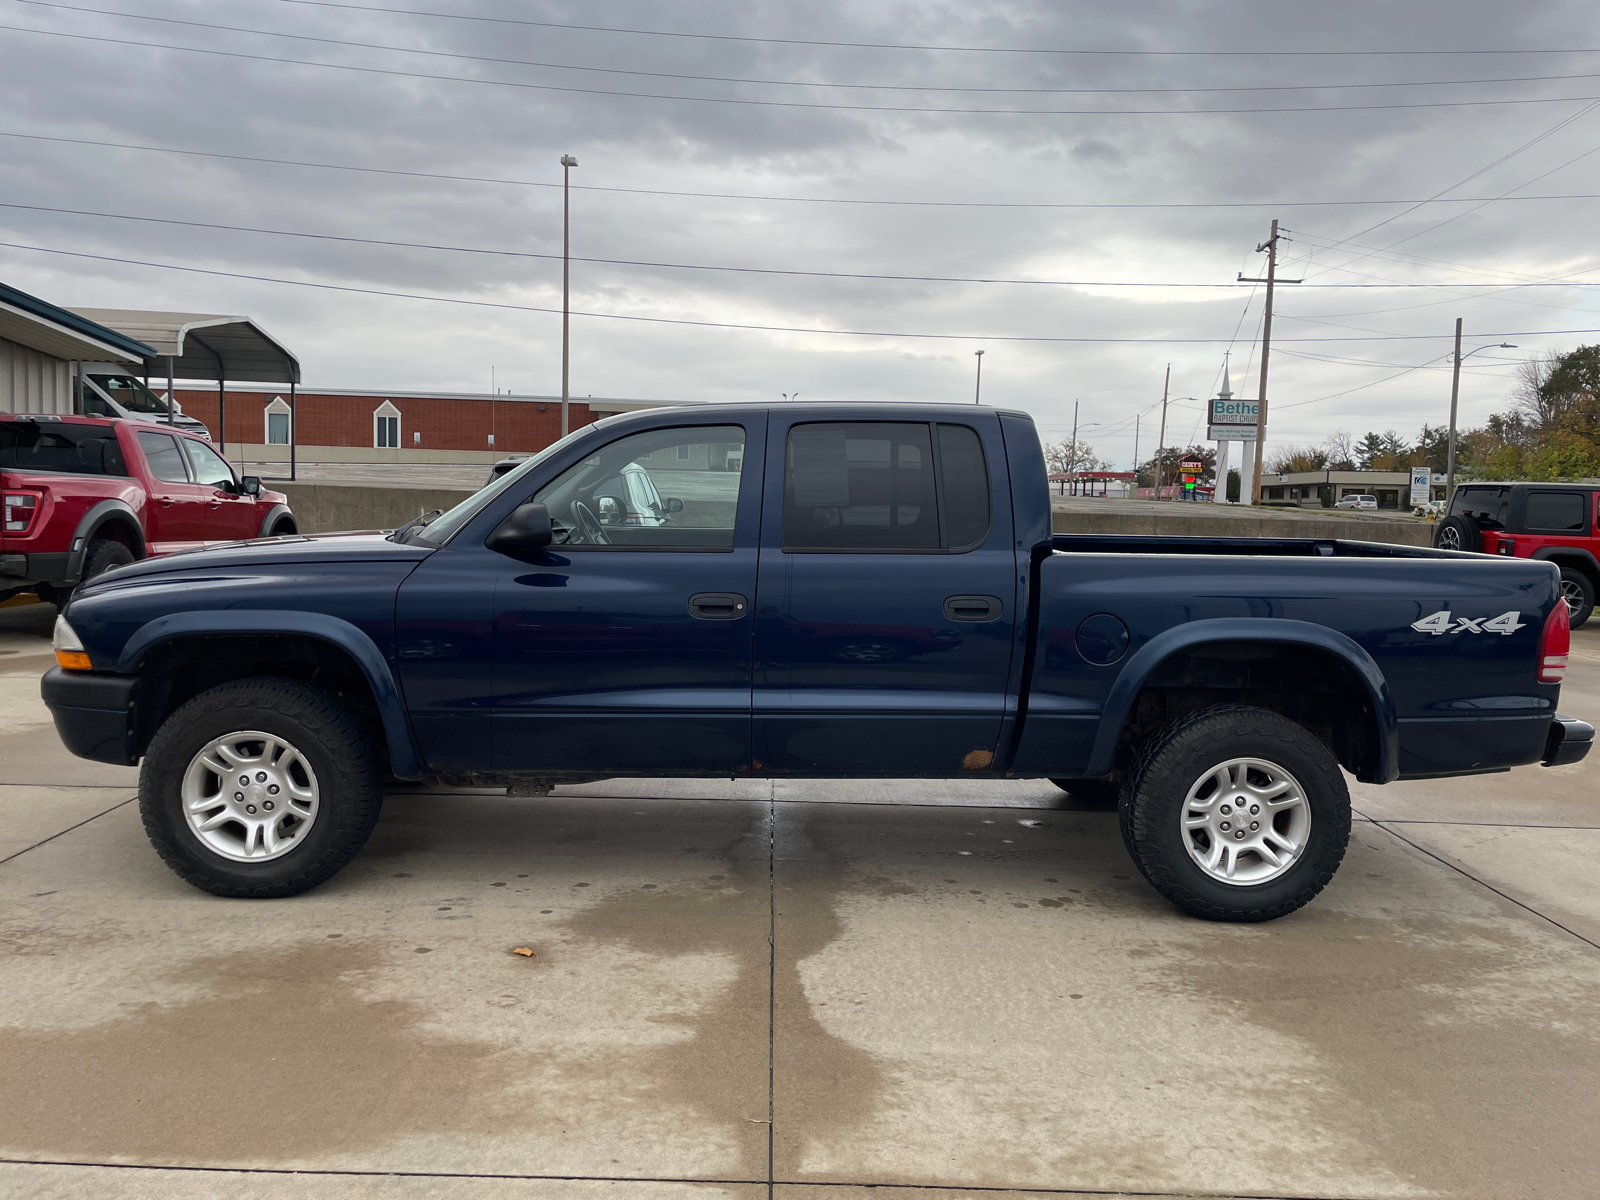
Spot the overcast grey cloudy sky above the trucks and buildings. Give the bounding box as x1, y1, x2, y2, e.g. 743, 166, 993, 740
0, 0, 1600, 462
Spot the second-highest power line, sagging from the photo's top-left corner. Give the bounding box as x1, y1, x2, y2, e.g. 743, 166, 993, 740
13, 0, 1600, 96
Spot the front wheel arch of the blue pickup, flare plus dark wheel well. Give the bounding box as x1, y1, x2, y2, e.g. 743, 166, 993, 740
117, 611, 422, 779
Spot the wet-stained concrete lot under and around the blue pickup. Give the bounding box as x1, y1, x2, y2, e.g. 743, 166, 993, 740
0, 606, 1600, 1200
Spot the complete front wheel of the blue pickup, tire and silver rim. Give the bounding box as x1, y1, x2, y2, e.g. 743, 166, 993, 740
139, 678, 382, 899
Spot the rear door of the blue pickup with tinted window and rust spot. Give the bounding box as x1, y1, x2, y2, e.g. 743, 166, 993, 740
754, 413, 1018, 776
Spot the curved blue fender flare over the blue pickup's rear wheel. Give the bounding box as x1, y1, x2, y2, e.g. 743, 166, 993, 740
1085, 618, 1400, 782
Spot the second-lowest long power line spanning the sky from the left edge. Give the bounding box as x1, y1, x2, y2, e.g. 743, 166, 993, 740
9, 202, 1600, 291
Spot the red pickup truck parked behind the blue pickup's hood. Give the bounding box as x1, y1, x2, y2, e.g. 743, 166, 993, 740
0, 413, 298, 603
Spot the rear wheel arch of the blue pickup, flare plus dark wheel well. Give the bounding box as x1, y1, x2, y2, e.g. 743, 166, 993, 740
1083, 618, 1400, 782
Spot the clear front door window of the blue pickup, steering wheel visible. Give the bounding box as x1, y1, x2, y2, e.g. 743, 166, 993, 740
533, 426, 744, 550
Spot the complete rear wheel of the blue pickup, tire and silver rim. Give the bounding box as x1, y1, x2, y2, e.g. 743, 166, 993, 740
1122, 704, 1350, 922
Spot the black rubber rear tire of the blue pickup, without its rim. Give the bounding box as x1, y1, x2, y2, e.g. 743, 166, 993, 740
1122, 704, 1350, 922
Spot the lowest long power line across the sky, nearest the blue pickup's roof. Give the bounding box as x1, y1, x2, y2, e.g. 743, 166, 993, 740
12, 242, 1600, 346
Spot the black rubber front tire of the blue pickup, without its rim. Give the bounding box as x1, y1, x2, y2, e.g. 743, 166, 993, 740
139, 678, 382, 899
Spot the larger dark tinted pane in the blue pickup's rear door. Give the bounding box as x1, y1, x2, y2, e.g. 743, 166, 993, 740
784, 421, 939, 550
